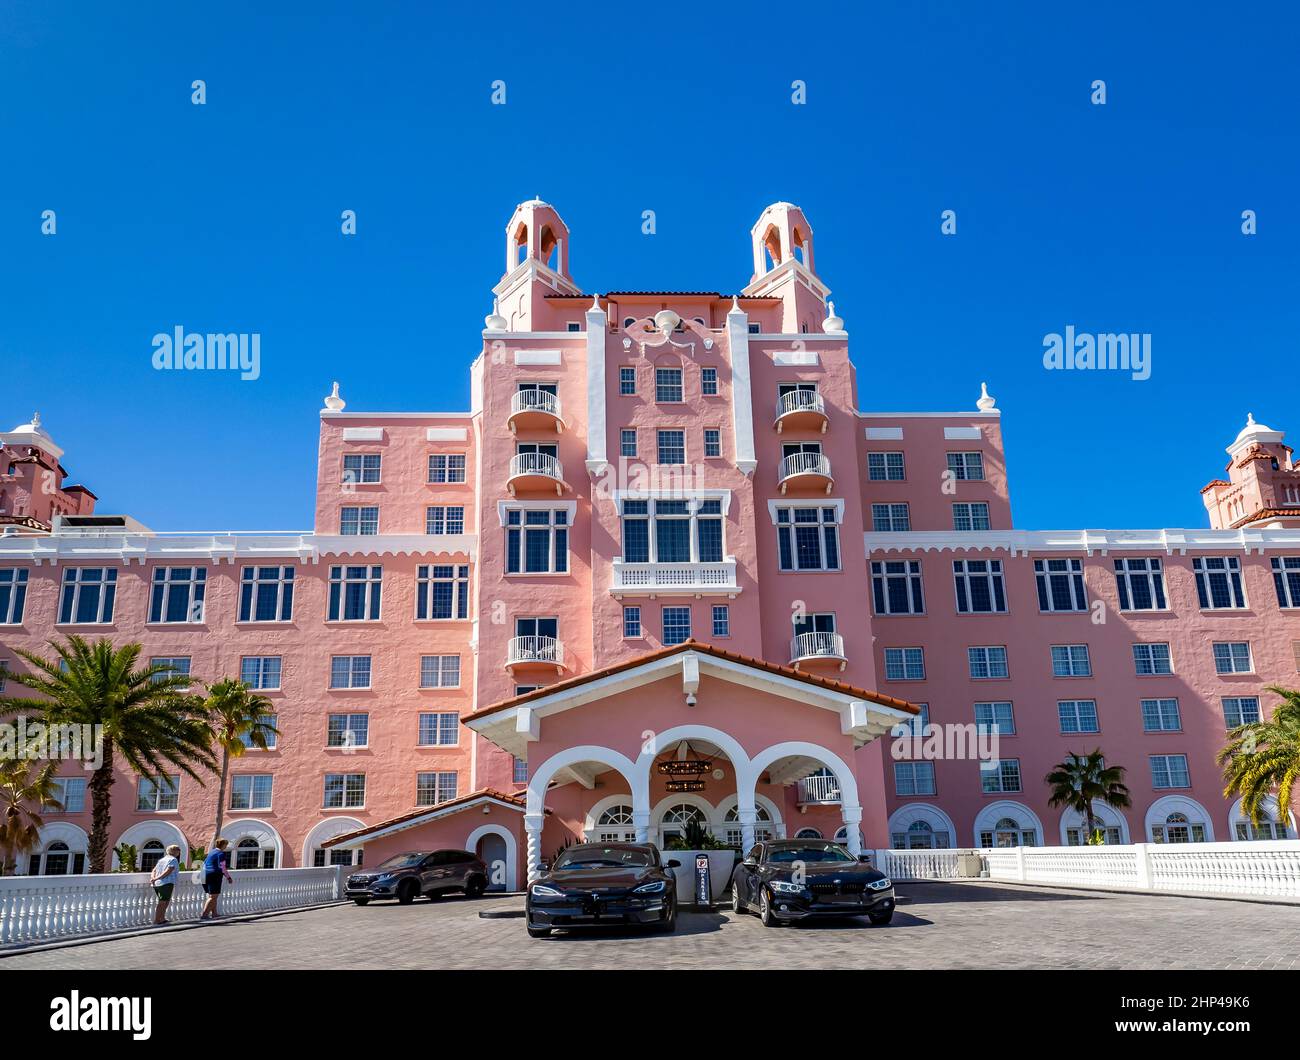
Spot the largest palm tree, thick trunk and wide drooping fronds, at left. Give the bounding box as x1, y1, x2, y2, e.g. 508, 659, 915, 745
0, 636, 216, 873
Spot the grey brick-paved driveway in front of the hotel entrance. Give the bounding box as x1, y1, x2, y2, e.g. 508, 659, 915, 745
0, 883, 1300, 972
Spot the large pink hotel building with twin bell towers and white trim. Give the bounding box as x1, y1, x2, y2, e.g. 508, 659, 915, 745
0, 200, 1300, 887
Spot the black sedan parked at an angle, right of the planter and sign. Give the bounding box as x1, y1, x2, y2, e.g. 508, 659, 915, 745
732, 839, 894, 927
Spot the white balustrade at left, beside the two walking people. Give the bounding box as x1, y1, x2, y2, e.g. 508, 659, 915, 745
0, 865, 343, 946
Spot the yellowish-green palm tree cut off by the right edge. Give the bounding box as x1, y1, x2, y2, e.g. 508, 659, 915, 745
1218, 684, 1300, 826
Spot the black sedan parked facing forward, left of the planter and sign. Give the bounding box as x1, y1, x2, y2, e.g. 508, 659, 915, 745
527, 843, 680, 939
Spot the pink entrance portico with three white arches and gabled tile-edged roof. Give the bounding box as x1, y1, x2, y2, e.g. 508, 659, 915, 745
464, 641, 918, 879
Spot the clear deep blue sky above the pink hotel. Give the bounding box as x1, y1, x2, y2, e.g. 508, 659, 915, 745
0, 0, 1300, 529
